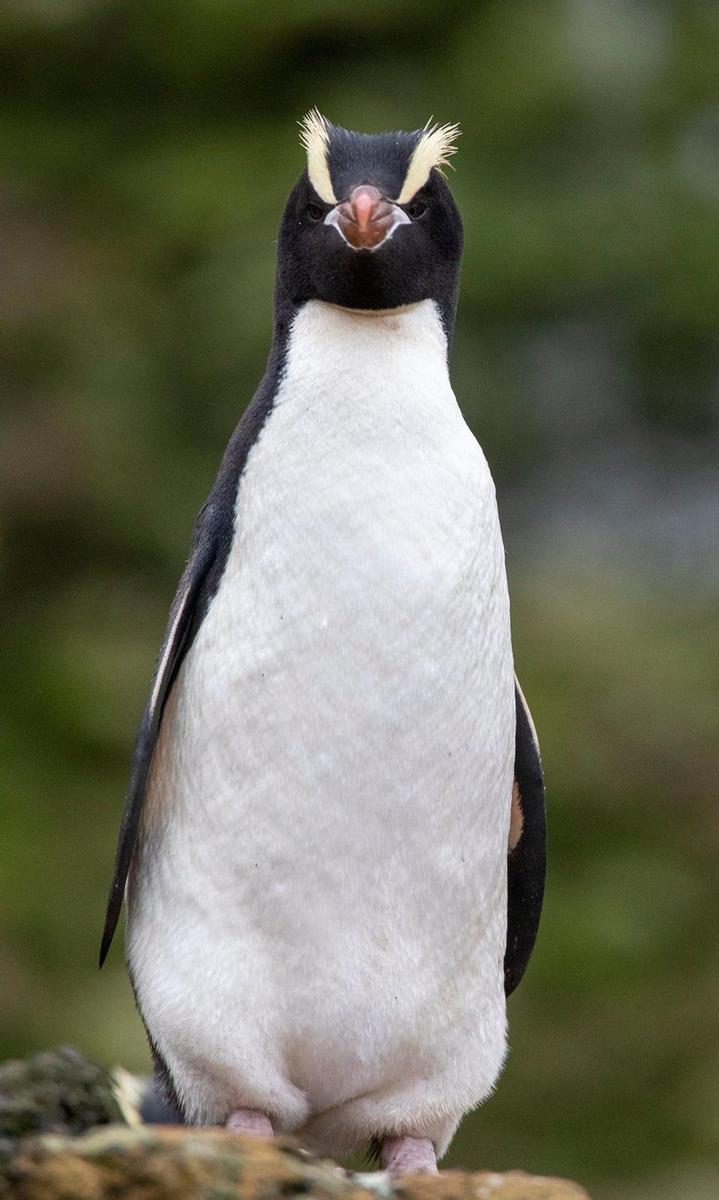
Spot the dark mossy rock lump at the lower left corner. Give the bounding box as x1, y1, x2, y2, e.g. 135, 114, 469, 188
0, 1046, 124, 1154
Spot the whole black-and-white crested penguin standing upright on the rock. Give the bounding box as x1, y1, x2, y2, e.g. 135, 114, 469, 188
101, 109, 545, 1175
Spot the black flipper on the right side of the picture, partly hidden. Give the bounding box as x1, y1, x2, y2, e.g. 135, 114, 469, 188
504, 677, 546, 996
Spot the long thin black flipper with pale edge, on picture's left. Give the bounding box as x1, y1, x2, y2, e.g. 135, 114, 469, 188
100, 506, 221, 966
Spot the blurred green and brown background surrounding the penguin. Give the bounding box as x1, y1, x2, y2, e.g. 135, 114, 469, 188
0, 0, 719, 1200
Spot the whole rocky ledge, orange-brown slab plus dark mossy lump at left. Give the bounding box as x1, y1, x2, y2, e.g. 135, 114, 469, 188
0, 1050, 588, 1200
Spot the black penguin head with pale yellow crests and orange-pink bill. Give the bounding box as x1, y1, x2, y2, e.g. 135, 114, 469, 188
272, 109, 462, 330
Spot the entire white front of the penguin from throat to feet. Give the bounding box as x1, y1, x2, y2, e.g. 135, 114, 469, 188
128, 301, 514, 1152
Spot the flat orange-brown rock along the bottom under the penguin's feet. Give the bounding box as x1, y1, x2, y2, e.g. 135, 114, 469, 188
0, 1126, 588, 1200
